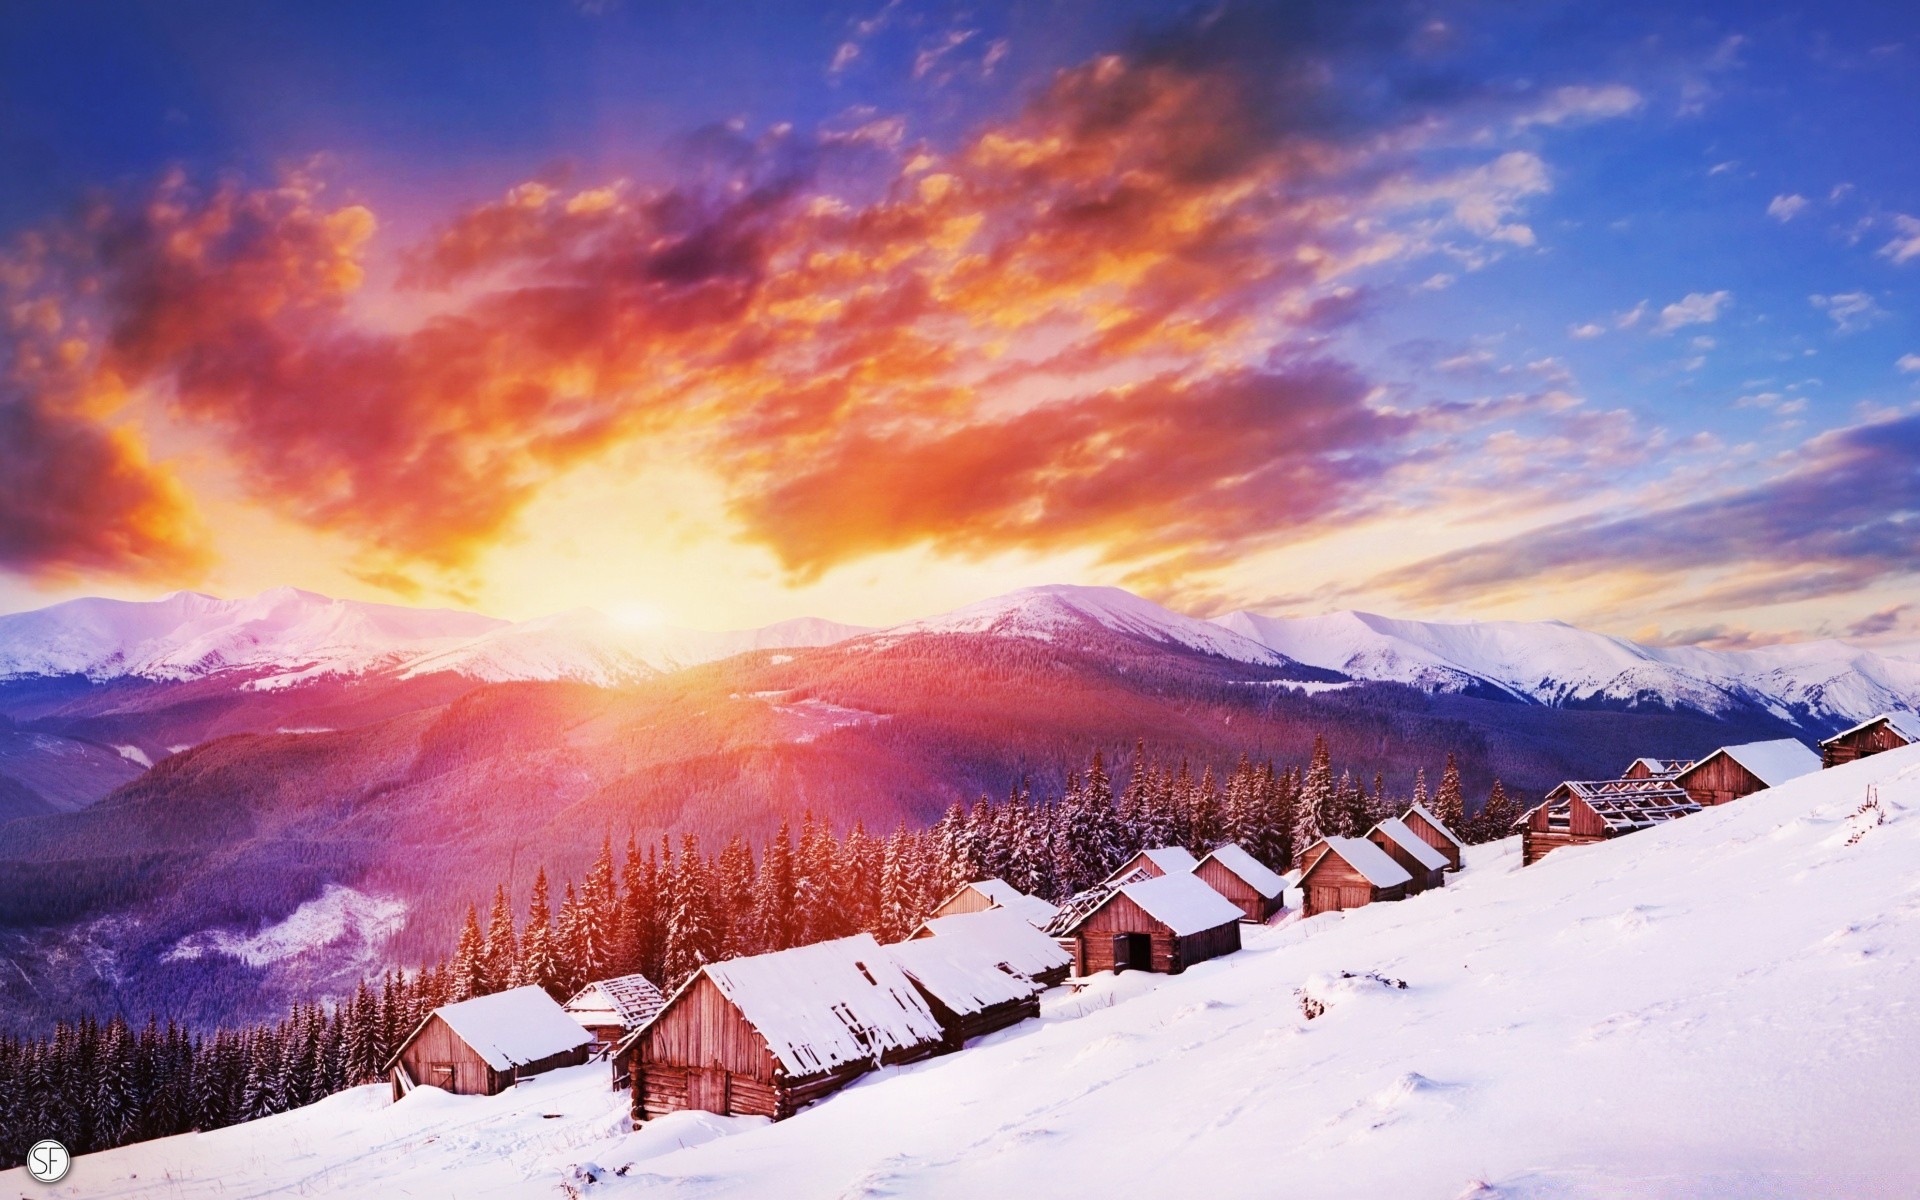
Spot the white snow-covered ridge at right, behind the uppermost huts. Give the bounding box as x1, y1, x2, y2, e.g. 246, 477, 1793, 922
1215, 612, 1920, 722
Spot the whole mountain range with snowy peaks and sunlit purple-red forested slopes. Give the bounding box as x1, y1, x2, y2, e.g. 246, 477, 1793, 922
0, 588, 1920, 1027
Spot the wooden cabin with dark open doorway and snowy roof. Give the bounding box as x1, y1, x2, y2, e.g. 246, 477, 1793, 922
1062, 872, 1242, 975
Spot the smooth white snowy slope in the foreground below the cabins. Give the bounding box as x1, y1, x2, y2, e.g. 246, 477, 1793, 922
15, 749, 1920, 1200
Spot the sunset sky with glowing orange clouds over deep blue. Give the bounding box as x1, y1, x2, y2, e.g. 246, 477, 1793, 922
0, 0, 1920, 647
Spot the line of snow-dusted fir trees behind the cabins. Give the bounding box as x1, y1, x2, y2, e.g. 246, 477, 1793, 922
0, 739, 1519, 1167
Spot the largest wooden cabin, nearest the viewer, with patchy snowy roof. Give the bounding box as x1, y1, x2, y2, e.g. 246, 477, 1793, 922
612, 933, 947, 1121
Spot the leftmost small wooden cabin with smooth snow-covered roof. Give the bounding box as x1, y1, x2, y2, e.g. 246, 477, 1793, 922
386, 987, 593, 1100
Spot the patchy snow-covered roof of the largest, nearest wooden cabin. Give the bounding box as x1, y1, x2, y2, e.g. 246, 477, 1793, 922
702, 933, 941, 1075
